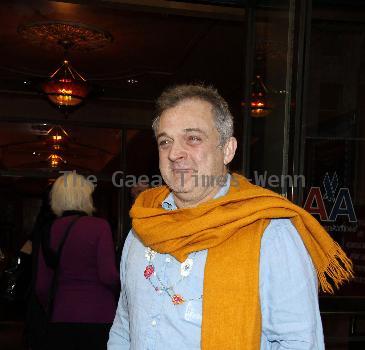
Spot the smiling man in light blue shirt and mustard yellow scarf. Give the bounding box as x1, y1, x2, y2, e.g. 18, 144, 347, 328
108, 85, 352, 350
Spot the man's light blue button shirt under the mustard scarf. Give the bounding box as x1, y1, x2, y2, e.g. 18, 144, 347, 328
108, 179, 324, 350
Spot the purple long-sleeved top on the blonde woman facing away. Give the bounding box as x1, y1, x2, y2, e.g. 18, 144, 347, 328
36, 216, 119, 323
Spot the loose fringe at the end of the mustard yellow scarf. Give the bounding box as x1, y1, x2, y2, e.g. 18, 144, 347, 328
317, 241, 354, 294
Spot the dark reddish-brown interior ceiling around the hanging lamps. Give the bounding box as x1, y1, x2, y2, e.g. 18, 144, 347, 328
0, 0, 245, 173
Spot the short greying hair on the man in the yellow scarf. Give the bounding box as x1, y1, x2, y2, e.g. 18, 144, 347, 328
152, 84, 233, 146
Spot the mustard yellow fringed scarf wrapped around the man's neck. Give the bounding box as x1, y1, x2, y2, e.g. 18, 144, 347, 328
130, 174, 353, 350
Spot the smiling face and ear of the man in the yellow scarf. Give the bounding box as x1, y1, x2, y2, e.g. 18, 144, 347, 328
157, 99, 235, 207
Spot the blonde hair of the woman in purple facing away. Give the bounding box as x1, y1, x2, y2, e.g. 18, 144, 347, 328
50, 171, 95, 216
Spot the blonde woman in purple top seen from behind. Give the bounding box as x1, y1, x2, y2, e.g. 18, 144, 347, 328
36, 172, 119, 350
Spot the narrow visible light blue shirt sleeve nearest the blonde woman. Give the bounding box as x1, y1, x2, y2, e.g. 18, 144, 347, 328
108, 231, 133, 350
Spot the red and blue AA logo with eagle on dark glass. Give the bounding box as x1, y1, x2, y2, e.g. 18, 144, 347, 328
304, 173, 357, 222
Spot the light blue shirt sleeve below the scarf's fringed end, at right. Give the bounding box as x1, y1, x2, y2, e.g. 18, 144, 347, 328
260, 219, 324, 350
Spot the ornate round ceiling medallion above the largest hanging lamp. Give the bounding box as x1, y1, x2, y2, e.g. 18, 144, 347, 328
18, 21, 113, 51
